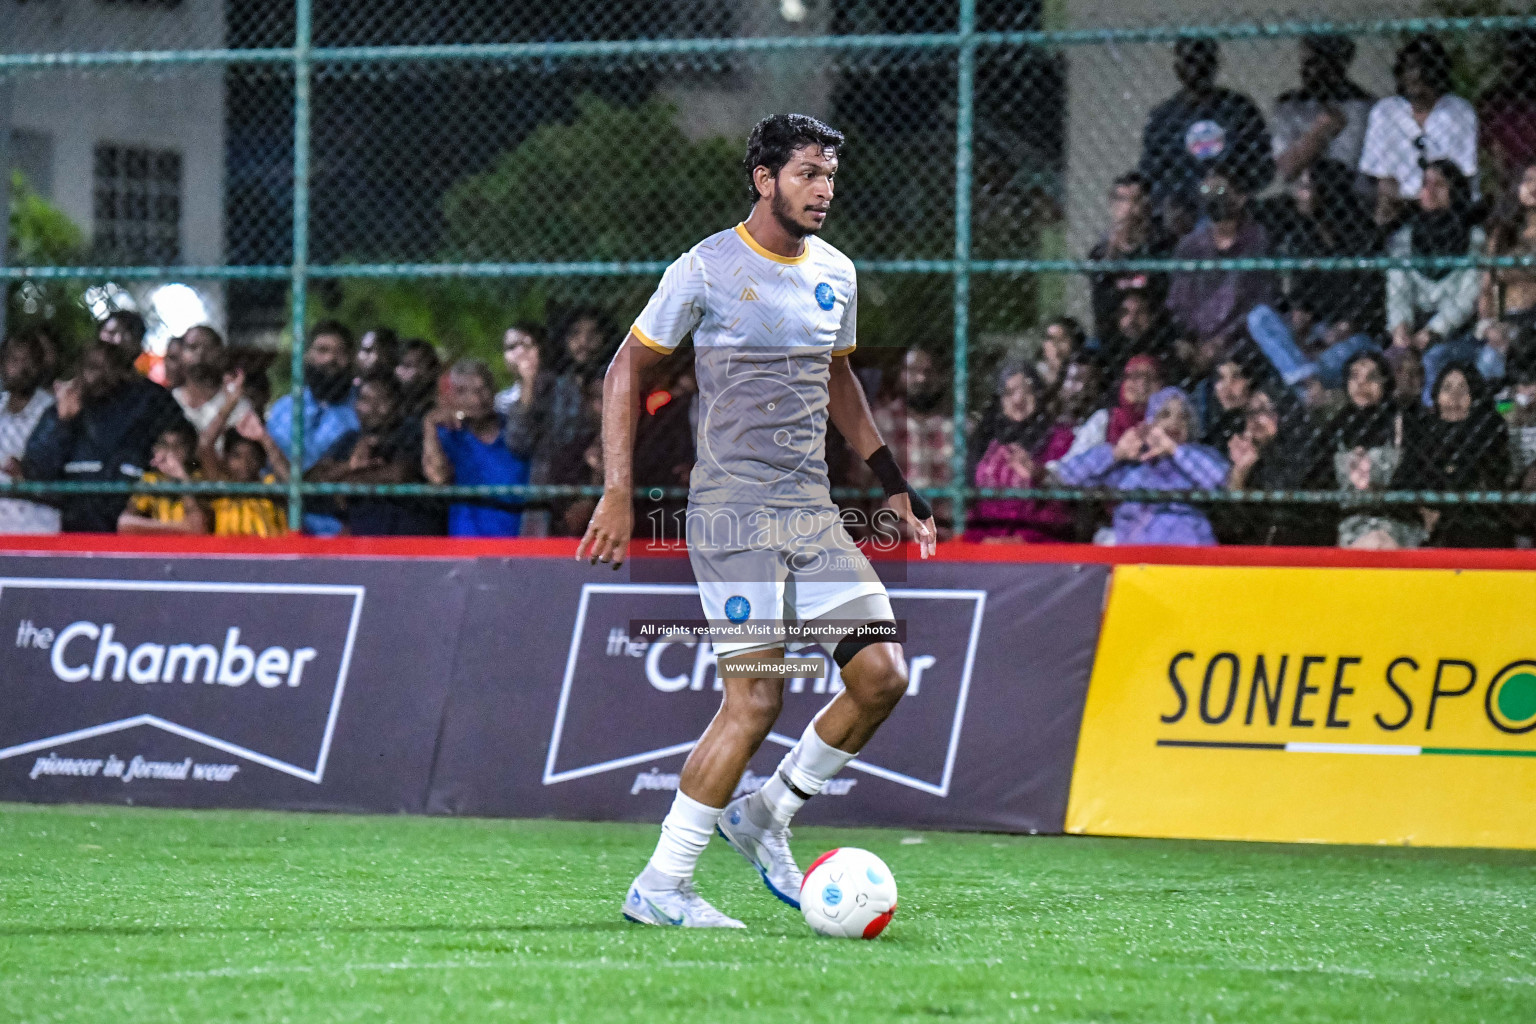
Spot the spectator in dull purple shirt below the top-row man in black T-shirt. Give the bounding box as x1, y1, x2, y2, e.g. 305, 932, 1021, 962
1167, 167, 1275, 376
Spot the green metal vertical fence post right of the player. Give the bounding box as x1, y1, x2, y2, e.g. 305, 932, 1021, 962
949, 0, 975, 537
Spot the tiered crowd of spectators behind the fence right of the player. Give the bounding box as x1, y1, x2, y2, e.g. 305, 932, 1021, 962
969, 32, 1536, 548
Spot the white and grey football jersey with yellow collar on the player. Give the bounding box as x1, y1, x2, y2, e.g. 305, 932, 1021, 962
631, 224, 859, 508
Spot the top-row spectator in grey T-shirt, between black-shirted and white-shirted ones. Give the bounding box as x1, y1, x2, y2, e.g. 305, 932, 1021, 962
1275, 35, 1375, 184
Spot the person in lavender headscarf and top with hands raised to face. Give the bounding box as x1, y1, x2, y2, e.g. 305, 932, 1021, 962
1055, 387, 1230, 547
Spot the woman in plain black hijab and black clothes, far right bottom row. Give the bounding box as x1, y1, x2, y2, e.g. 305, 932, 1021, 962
1395, 362, 1514, 548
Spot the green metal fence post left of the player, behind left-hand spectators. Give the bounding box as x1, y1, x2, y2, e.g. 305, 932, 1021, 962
289, 0, 313, 531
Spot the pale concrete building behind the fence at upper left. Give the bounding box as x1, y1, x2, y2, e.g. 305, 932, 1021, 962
5, 0, 226, 342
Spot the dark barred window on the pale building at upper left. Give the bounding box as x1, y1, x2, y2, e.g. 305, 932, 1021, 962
95, 143, 181, 264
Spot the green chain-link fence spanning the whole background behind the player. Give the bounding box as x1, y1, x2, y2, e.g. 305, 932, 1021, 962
0, 0, 1536, 547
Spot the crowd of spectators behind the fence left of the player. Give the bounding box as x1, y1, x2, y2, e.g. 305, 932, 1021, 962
0, 310, 629, 537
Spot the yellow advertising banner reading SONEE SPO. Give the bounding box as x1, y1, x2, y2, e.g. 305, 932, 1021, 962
1066, 565, 1536, 847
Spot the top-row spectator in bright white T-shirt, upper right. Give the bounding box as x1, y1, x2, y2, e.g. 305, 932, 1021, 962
1359, 35, 1478, 224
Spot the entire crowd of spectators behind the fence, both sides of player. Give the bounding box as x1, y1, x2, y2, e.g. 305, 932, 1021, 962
9, 32, 1536, 548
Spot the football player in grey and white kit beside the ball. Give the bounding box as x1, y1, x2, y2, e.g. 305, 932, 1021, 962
576, 114, 934, 927
